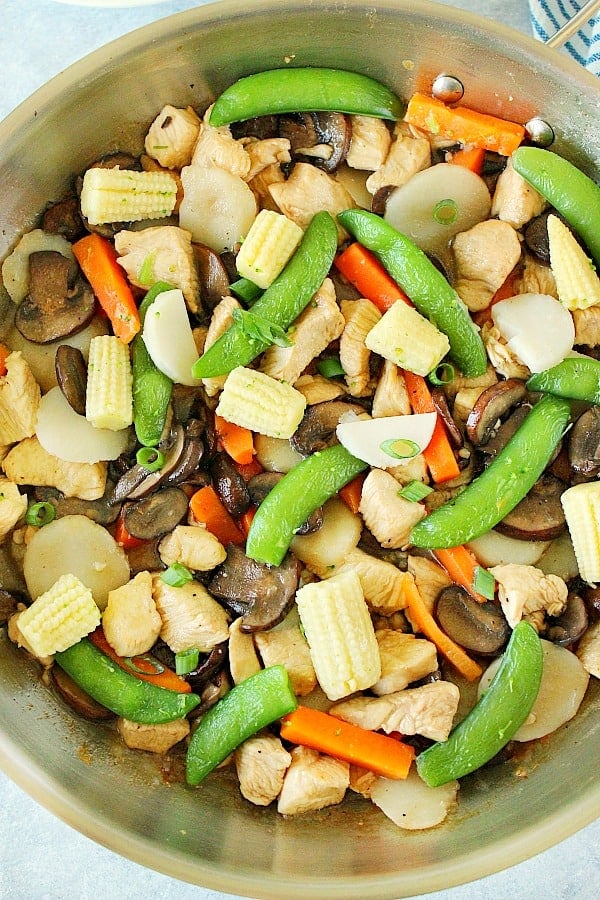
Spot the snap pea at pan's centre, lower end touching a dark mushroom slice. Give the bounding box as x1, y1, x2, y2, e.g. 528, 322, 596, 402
246, 444, 367, 566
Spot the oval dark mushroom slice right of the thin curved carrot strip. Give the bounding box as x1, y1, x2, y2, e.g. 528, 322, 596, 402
436, 584, 510, 656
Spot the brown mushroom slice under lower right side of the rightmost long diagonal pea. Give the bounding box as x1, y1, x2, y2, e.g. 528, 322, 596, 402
496, 472, 567, 541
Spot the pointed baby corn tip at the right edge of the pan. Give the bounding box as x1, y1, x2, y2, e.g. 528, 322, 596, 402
548, 215, 600, 310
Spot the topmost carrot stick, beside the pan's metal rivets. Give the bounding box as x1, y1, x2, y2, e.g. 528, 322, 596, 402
404, 93, 525, 156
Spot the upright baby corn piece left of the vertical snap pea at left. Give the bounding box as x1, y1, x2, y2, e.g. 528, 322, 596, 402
85, 334, 133, 431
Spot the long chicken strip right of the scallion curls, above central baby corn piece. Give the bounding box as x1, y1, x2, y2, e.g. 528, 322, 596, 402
259, 278, 344, 384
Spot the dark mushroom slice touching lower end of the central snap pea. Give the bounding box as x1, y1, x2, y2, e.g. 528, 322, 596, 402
208, 545, 299, 634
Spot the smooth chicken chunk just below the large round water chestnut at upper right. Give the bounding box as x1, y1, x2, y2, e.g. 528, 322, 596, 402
452, 219, 521, 312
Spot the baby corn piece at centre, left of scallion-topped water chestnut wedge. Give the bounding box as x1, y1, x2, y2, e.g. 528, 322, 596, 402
216, 366, 306, 438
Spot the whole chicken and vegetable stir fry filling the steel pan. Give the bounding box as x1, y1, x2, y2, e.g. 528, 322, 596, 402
0, 68, 600, 829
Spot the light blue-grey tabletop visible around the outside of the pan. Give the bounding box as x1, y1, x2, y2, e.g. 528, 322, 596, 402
0, 0, 600, 900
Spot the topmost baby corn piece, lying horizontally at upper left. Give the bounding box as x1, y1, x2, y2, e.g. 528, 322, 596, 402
81, 168, 177, 225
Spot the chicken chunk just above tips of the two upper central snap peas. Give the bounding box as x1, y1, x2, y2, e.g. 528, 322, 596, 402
269, 163, 355, 241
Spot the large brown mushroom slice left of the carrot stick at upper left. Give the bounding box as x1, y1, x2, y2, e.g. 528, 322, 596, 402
15, 250, 95, 344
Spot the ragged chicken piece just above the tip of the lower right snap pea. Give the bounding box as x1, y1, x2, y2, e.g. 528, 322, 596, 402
490, 563, 569, 631
